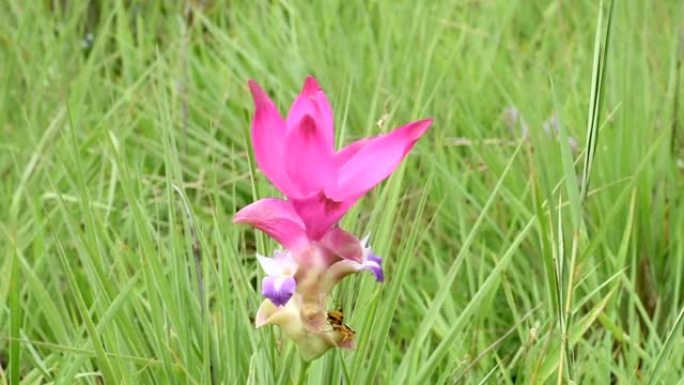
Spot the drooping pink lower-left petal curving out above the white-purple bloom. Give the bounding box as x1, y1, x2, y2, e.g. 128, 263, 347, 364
233, 198, 307, 250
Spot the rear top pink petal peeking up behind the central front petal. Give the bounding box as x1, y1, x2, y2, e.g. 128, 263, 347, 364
286, 76, 335, 150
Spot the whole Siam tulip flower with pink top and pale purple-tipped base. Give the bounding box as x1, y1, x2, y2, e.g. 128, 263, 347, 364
233, 77, 432, 360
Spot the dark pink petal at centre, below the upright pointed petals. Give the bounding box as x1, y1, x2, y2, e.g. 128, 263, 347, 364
292, 192, 358, 240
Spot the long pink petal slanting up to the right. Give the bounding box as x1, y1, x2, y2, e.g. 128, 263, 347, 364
325, 119, 432, 201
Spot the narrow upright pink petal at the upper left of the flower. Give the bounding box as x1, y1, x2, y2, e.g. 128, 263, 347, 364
249, 80, 290, 193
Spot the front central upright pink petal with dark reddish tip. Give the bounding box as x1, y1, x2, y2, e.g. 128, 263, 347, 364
285, 115, 335, 199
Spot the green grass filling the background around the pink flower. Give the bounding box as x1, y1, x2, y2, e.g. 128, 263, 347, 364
0, 0, 684, 384
